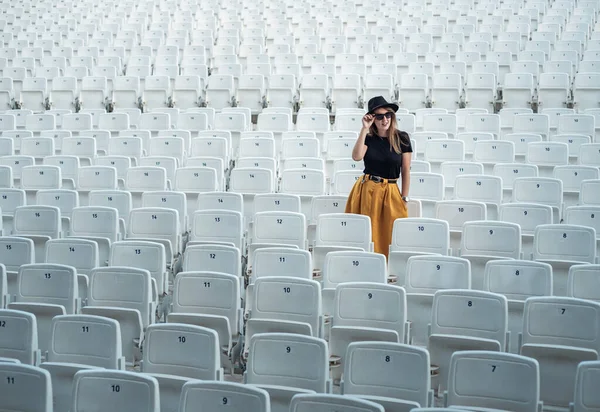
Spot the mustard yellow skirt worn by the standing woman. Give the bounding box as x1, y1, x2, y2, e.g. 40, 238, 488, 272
346, 175, 408, 258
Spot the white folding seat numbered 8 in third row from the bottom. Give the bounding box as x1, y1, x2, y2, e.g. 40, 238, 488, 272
428, 290, 510, 390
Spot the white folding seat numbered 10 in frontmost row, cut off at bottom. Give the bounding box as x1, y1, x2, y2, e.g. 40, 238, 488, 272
71, 369, 160, 412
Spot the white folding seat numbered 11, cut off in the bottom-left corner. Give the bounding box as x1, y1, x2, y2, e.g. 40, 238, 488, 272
0, 362, 53, 412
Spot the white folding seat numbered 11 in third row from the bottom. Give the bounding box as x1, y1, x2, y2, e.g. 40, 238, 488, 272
167, 271, 242, 368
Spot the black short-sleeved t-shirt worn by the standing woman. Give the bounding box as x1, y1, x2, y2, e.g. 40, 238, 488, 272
363, 131, 412, 179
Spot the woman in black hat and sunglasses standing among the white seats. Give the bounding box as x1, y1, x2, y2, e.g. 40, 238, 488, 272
346, 96, 412, 257
